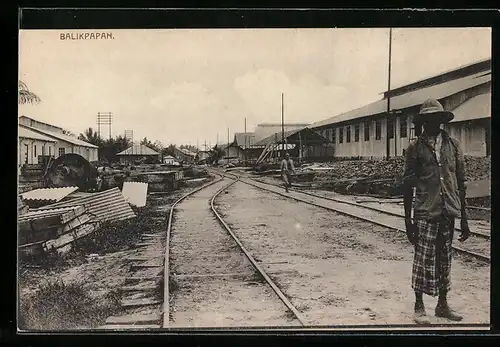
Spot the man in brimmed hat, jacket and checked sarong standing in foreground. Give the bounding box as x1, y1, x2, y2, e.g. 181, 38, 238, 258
403, 99, 470, 324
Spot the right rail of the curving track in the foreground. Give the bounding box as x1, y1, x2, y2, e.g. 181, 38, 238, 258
210, 175, 306, 326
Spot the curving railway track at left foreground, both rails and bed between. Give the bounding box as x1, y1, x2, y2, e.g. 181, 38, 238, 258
162, 176, 305, 328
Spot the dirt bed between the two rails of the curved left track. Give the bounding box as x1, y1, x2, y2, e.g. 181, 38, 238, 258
170, 179, 299, 327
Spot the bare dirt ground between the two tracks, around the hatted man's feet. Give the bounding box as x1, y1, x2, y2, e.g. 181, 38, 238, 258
218, 183, 490, 325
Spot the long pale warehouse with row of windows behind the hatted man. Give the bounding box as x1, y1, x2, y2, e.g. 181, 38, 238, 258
310, 59, 491, 158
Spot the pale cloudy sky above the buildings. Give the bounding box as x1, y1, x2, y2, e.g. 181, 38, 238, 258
19, 28, 491, 148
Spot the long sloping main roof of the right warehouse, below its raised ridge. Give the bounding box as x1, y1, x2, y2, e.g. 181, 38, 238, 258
311, 71, 491, 128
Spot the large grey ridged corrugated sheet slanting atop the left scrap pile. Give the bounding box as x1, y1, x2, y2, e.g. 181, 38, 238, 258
34, 187, 135, 221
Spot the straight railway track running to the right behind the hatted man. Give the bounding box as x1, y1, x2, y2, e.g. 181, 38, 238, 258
218, 169, 491, 263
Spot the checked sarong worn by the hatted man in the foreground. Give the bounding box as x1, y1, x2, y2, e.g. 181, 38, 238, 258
412, 217, 455, 296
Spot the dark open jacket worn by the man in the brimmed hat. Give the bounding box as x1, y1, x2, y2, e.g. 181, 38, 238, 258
403, 131, 466, 220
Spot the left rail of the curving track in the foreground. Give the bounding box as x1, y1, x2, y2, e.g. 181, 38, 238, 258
162, 173, 224, 328
